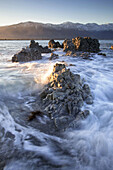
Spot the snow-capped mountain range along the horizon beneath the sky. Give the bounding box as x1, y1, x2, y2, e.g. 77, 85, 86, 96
0, 21, 113, 40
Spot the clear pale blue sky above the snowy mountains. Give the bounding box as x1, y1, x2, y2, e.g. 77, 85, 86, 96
0, 0, 113, 26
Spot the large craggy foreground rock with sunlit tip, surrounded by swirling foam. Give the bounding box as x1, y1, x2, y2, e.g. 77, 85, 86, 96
40, 63, 93, 130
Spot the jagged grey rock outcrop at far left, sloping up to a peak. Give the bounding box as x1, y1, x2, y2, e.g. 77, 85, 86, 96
12, 40, 51, 62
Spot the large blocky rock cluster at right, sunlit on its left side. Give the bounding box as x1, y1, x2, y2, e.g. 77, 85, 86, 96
63, 37, 100, 53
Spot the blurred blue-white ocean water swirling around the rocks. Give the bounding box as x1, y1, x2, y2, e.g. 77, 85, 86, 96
0, 40, 113, 170
